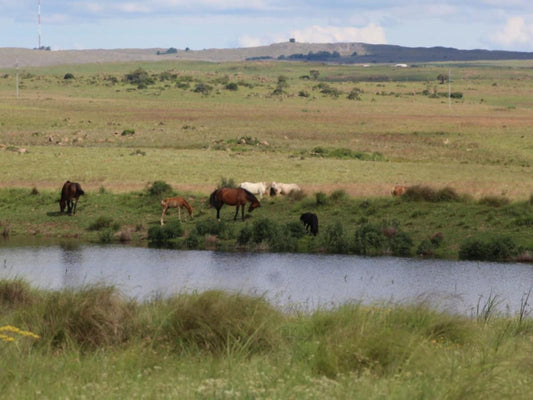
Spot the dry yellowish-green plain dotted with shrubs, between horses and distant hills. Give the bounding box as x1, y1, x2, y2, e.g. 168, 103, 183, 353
0, 61, 533, 200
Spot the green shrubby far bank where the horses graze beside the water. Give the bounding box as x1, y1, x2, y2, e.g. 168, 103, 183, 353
0, 181, 533, 261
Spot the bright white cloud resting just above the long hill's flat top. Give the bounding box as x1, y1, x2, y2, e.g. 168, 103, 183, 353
290, 24, 387, 44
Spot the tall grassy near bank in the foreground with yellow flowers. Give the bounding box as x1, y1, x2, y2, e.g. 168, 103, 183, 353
0, 281, 533, 399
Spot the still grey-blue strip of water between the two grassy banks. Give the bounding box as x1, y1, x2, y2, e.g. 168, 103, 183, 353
0, 243, 533, 315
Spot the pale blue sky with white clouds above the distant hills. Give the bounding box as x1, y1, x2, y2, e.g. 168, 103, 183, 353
0, 0, 533, 51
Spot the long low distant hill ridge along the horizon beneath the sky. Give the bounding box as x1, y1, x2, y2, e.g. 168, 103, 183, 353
0, 42, 533, 68
